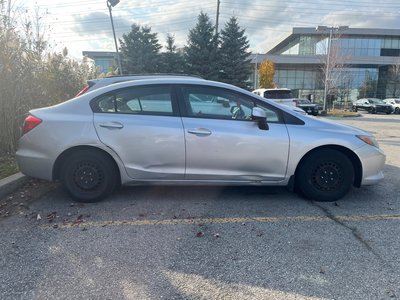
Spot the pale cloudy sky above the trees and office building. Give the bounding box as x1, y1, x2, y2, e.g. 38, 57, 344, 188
6, 0, 400, 59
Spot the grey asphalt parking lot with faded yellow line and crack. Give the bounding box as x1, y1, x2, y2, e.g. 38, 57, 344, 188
0, 114, 400, 299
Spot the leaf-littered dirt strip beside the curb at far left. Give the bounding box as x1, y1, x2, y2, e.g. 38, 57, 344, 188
0, 179, 59, 219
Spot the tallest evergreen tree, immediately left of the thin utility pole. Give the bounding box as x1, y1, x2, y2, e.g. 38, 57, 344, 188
185, 12, 219, 80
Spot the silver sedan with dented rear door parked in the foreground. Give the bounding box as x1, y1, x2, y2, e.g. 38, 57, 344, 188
17, 77, 385, 202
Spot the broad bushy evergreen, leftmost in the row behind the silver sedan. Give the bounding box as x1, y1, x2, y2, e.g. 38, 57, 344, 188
120, 24, 161, 74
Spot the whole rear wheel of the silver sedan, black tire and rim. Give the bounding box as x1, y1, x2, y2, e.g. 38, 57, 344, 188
61, 150, 119, 203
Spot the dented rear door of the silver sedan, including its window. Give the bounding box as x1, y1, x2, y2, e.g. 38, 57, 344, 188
91, 85, 185, 180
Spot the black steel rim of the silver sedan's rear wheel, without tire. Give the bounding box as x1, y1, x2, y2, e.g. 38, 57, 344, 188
73, 161, 104, 190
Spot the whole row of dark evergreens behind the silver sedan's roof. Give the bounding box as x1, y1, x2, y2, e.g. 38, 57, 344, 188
120, 12, 251, 88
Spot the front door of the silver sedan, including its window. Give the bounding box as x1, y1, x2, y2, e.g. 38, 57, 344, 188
180, 86, 289, 181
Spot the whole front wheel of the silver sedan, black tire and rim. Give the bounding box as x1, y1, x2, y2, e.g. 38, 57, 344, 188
296, 149, 354, 202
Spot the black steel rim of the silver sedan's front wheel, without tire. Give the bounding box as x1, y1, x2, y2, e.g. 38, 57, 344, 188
312, 162, 343, 191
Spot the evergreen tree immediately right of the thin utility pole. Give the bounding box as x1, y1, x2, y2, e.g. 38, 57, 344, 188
219, 17, 251, 88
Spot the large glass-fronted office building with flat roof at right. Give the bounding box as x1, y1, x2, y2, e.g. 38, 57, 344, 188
252, 27, 400, 101
